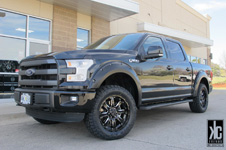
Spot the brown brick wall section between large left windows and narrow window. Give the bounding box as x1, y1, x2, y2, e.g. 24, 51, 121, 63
52, 5, 77, 52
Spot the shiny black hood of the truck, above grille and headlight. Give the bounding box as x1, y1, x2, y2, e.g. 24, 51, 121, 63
26, 50, 137, 59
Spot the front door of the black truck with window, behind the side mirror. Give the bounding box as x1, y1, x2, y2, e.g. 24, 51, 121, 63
139, 36, 174, 103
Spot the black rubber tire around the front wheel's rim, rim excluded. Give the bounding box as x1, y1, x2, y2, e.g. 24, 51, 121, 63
85, 85, 137, 140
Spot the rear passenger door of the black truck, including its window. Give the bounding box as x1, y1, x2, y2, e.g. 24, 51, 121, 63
166, 40, 192, 97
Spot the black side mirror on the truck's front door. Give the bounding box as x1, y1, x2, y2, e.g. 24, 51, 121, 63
145, 46, 163, 59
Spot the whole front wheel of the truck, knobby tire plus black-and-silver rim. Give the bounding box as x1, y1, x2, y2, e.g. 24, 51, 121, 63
85, 85, 137, 140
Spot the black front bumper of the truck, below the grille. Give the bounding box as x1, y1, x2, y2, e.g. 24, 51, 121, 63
14, 88, 96, 113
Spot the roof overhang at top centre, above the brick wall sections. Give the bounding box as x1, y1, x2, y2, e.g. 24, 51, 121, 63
39, 0, 139, 21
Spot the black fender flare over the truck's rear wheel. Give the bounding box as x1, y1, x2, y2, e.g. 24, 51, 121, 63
193, 71, 209, 97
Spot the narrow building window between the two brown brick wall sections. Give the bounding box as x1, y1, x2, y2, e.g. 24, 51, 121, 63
77, 28, 89, 49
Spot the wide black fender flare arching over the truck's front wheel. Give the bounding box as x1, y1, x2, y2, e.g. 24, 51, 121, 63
89, 61, 142, 104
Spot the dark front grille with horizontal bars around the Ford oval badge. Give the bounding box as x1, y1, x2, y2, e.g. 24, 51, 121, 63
19, 59, 57, 89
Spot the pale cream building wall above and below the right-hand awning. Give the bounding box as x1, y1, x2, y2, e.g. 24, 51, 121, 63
110, 0, 210, 63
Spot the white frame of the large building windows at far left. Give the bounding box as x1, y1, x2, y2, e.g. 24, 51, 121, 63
0, 7, 52, 61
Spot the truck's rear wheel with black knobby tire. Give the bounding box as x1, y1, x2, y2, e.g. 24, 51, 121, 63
189, 83, 209, 113
